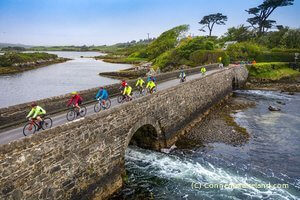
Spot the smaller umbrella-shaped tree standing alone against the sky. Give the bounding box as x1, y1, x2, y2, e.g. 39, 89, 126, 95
199, 13, 227, 36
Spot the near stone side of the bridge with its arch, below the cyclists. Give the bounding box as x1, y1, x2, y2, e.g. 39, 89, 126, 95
0, 66, 248, 200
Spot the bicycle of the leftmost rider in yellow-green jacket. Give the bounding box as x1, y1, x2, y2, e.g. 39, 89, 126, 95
23, 117, 52, 136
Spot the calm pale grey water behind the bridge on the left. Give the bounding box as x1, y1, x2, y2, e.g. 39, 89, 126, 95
0, 51, 130, 107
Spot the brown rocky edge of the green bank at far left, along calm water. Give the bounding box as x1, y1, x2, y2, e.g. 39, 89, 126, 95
0, 58, 71, 76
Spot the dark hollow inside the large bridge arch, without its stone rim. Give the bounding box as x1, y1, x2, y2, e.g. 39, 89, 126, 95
129, 124, 158, 149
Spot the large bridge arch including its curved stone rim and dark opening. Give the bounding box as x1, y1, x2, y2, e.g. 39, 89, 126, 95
125, 116, 162, 150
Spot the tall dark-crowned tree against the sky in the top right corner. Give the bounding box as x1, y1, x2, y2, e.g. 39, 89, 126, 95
246, 0, 294, 36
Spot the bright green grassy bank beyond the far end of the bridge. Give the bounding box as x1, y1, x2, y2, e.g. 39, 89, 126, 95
248, 62, 300, 80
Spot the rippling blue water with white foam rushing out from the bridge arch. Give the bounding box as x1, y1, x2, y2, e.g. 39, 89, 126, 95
116, 91, 300, 200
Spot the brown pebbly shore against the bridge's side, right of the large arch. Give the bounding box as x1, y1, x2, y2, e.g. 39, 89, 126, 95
175, 94, 255, 149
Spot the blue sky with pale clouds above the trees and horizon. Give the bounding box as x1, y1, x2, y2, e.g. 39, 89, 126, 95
0, 0, 300, 46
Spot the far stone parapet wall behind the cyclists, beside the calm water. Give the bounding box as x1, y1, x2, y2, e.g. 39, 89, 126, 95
0, 64, 217, 130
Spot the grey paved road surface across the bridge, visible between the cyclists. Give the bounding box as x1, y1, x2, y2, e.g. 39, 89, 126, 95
0, 70, 223, 145
